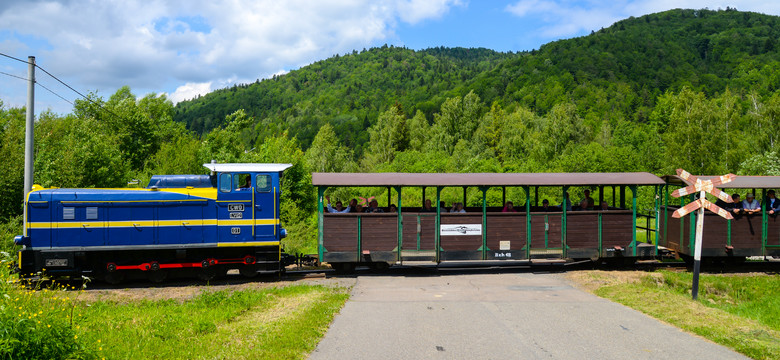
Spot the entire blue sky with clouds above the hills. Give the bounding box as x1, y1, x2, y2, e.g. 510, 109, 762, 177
0, 0, 780, 114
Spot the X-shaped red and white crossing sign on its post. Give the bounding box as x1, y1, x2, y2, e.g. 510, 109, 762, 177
672, 169, 737, 300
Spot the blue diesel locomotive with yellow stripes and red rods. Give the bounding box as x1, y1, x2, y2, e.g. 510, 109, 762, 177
14, 162, 291, 283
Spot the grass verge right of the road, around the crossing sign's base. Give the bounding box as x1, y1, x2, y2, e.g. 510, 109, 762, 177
570, 271, 780, 359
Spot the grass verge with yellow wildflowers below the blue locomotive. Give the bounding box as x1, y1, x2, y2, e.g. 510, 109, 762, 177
0, 272, 349, 359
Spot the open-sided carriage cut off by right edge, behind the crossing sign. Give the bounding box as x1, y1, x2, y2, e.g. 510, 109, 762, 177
659, 175, 780, 263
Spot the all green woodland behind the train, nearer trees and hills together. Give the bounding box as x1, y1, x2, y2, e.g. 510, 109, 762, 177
0, 9, 780, 252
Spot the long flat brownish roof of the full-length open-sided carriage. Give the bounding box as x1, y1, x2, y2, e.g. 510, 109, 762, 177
312, 172, 664, 186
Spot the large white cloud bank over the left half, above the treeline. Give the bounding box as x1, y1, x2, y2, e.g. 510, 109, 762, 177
0, 0, 463, 111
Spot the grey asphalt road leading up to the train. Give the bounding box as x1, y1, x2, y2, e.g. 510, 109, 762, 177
310, 273, 746, 360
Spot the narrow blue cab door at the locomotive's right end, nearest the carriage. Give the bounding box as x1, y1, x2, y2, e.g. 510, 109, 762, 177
253, 174, 279, 241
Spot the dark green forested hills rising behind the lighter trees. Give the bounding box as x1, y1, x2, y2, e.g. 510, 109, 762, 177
175, 9, 780, 155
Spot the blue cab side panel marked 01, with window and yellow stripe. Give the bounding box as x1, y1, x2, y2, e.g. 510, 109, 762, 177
217, 173, 253, 243
